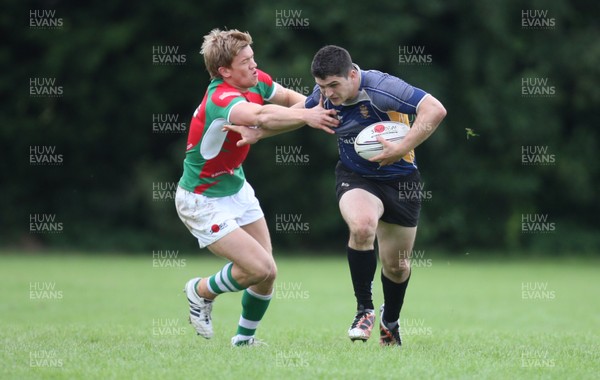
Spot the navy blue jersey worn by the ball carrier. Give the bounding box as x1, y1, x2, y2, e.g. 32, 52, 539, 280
305, 65, 427, 181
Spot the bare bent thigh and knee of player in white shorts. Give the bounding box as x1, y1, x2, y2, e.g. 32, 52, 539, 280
208, 228, 275, 277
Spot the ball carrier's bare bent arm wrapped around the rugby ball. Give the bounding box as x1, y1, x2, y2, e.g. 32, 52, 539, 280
369, 95, 446, 166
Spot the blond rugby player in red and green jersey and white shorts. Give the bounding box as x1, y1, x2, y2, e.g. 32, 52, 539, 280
175, 29, 339, 346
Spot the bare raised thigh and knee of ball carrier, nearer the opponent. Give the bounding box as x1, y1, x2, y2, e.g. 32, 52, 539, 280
339, 188, 383, 231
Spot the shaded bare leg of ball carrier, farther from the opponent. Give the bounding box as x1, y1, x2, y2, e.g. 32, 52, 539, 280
377, 221, 417, 273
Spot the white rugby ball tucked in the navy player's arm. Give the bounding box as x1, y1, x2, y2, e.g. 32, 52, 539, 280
354, 121, 410, 160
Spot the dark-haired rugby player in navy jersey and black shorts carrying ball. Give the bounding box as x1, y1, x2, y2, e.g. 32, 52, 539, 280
229, 45, 446, 346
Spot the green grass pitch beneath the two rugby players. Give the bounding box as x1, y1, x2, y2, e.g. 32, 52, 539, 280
0, 252, 600, 380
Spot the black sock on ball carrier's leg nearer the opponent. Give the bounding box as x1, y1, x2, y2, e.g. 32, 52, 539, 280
347, 247, 377, 310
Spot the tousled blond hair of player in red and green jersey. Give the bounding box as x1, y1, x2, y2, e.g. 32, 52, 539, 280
200, 29, 252, 78
